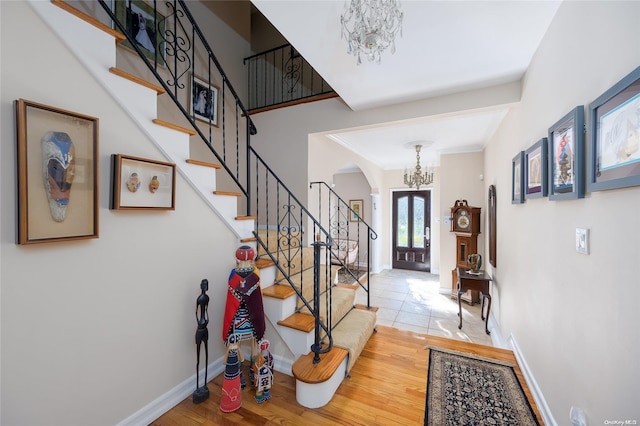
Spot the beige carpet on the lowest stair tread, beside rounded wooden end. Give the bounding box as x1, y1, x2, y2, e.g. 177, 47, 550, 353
331, 309, 376, 373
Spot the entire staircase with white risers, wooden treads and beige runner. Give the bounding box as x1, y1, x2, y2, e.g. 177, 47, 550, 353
45, 0, 376, 408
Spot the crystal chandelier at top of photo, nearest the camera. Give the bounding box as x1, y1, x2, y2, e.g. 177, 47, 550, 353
340, 0, 402, 65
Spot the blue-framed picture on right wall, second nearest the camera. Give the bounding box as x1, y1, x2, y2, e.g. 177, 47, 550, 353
549, 106, 585, 200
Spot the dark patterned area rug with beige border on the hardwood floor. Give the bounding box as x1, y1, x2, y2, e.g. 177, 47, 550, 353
424, 348, 539, 426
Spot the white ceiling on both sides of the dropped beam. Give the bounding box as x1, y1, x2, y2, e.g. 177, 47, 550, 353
252, 0, 561, 169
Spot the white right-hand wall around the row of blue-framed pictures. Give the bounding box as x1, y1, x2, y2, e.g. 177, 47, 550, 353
484, 1, 640, 425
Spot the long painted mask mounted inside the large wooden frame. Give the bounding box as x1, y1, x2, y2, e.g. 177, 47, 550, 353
42, 132, 75, 222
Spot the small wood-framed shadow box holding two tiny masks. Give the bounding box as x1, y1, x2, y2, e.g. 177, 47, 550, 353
111, 154, 176, 210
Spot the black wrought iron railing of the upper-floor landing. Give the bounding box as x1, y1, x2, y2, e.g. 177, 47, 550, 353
244, 44, 338, 113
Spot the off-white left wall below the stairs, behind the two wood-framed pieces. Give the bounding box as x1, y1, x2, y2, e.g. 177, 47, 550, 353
0, 2, 244, 425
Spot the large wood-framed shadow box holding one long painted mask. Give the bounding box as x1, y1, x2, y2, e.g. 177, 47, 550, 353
15, 99, 99, 244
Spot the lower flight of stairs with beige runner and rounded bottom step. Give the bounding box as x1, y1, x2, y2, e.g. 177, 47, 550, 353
256, 233, 377, 408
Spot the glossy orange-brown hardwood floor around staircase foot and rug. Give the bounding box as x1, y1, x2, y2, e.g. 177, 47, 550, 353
151, 326, 543, 426
